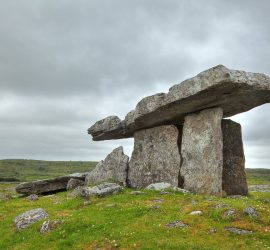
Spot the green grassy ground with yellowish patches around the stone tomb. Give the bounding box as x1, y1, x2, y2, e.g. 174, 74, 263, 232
0, 165, 270, 250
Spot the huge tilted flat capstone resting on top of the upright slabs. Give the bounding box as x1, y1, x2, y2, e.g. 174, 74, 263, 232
88, 65, 270, 141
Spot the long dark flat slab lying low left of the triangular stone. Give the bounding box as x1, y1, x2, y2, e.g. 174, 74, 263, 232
15, 173, 86, 195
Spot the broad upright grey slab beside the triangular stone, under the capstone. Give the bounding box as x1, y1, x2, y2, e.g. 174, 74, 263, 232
128, 125, 181, 188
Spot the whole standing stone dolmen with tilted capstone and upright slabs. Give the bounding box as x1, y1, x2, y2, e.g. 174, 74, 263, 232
86, 65, 270, 195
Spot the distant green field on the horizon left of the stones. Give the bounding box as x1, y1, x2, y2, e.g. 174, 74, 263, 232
0, 160, 97, 181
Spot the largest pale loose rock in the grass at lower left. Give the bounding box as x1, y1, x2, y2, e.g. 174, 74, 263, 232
14, 208, 48, 230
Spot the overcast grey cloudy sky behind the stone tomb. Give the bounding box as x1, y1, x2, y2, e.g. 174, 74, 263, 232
0, 0, 270, 167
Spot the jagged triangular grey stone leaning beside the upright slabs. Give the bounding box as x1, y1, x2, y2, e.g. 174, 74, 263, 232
86, 147, 129, 185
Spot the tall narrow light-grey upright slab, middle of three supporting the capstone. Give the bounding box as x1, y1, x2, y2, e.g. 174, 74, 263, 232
180, 108, 223, 195
